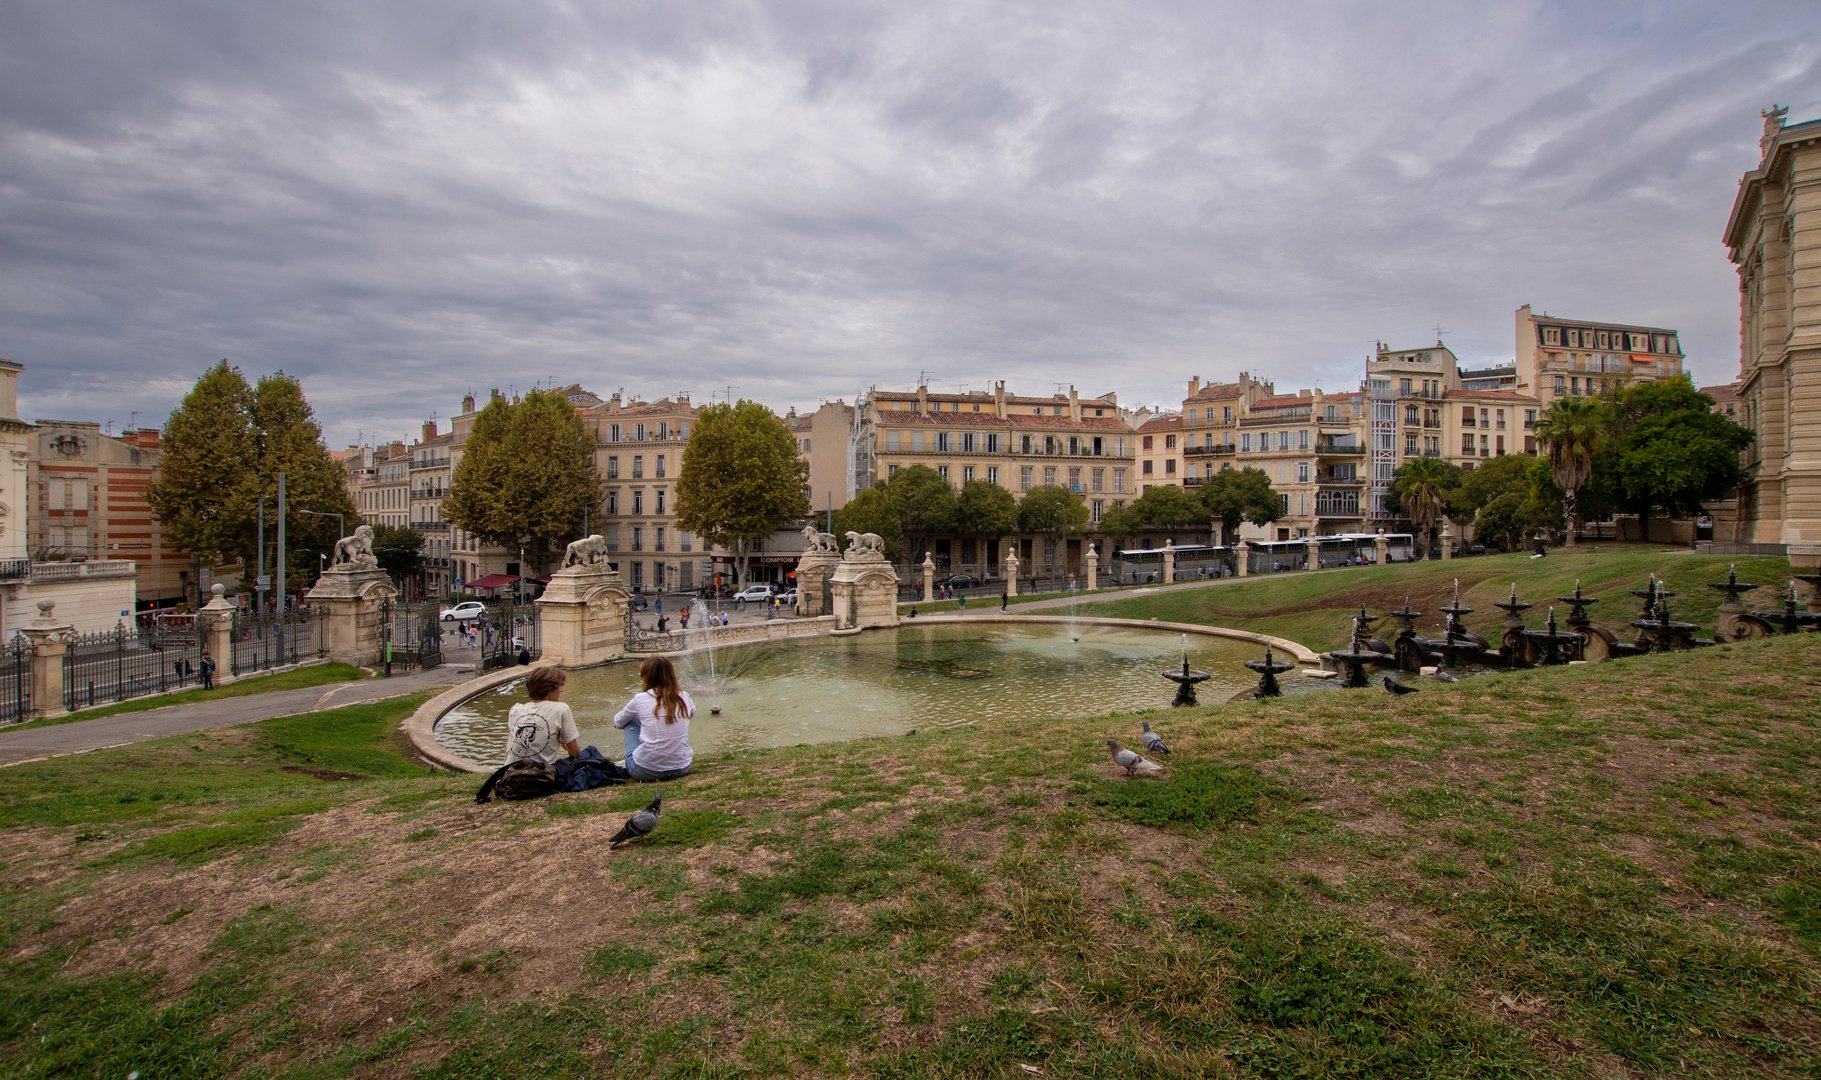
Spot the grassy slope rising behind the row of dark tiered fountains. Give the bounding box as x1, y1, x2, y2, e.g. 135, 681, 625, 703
1082, 545, 1806, 650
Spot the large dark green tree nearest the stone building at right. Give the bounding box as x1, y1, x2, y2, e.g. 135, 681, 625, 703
1590, 375, 1754, 539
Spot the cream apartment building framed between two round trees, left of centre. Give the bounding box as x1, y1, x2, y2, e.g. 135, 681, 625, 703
583, 393, 714, 592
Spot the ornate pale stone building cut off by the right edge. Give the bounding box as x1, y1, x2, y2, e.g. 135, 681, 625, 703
1724, 109, 1821, 566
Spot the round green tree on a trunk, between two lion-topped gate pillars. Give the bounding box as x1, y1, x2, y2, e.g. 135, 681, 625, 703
676, 401, 809, 585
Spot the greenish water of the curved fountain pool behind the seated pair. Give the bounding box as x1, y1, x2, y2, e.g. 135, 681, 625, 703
435, 623, 1326, 765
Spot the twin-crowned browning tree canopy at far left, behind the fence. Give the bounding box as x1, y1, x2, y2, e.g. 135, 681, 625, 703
146, 361, 357, 597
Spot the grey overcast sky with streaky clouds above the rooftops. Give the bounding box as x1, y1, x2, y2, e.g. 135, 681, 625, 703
0, 0, 1821, 446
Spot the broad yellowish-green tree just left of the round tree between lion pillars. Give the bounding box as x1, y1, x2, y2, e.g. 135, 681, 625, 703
443, 390, 600, 570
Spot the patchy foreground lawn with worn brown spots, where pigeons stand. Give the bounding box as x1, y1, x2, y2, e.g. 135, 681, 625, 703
0, 619, 1821, 1078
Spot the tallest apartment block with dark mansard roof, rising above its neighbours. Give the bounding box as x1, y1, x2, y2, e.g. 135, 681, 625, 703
1511, 304, 1683, 408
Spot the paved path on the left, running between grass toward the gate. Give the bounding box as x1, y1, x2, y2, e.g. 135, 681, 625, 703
0, 663, 473, 767
